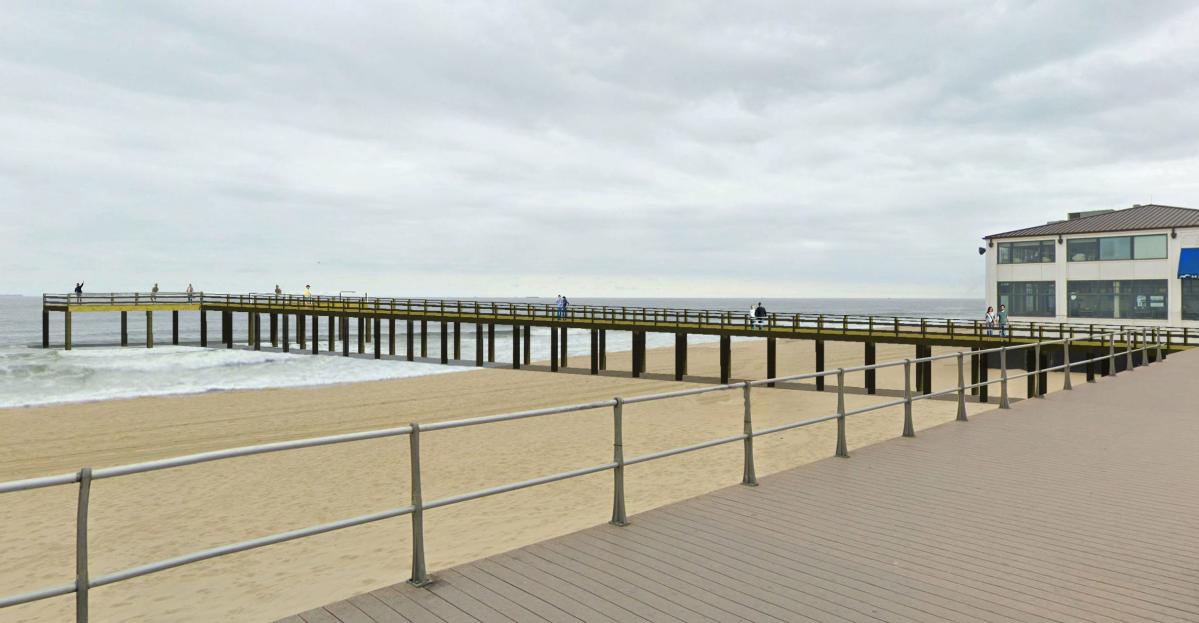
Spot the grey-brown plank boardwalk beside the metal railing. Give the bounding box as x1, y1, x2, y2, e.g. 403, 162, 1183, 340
283, 352, 1199, 623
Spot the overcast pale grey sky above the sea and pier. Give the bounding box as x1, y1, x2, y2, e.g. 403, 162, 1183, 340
0, 0, 1199, 297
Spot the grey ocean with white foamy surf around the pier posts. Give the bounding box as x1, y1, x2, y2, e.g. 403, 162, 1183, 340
0, 296, 983, 407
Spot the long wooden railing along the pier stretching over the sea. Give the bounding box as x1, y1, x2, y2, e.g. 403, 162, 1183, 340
42, 292, 1199, 347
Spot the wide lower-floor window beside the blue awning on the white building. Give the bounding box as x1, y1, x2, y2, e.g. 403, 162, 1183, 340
1066, 279, 1169, 320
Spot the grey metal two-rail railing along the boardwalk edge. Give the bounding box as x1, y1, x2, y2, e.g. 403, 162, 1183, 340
0, 332, 1164, 623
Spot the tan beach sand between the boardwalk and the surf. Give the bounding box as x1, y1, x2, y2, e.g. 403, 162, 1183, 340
0, 340, 1060, 622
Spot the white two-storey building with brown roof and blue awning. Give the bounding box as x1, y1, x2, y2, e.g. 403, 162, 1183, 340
983, 205, 1199, 327
